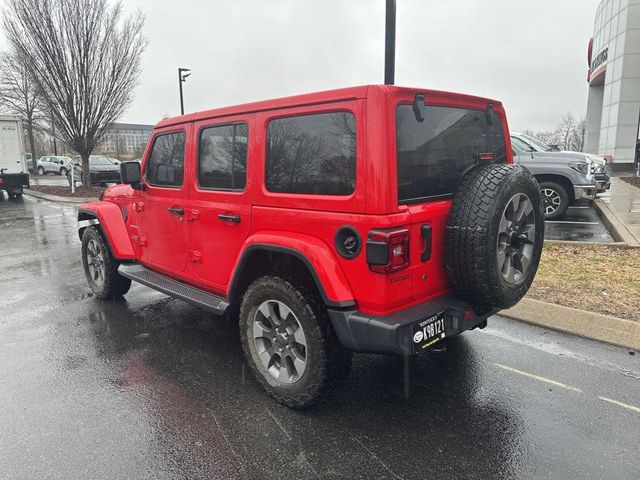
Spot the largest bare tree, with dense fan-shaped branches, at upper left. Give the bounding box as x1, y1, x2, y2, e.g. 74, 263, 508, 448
2, 0, 146, 186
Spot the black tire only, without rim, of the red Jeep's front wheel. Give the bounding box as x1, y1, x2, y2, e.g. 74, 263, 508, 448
82, 227, 131, 300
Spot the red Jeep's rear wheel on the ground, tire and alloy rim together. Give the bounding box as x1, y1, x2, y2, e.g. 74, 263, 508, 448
240, 276, 351, 408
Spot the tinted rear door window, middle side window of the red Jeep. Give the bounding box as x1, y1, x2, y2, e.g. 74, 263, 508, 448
198, 123, 249, 190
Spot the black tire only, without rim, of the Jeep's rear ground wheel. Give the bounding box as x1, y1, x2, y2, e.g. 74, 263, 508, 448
240, 275, 352, 409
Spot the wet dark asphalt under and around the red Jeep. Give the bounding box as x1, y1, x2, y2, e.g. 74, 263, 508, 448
0, 197, 640, 479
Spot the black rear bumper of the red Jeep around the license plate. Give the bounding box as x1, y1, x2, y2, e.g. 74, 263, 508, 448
329, 295, 497, 355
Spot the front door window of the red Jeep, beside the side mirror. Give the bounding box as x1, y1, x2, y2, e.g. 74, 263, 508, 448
146, 132, 184, 187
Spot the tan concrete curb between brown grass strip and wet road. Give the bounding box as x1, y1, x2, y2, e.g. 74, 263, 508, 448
498, 298, 640, 351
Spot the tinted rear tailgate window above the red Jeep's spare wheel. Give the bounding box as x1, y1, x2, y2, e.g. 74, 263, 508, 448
396, 105, 507, 203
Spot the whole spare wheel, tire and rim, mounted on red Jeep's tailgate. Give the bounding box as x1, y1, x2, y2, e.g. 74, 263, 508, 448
445, 165, 544, 310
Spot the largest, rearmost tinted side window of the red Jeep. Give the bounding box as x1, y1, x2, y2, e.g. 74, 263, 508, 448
266, 112, 356, 195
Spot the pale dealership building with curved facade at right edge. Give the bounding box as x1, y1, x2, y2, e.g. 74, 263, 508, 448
584, 0, 640, 168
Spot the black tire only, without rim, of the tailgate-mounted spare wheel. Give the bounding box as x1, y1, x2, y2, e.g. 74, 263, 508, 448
445, 165, 544, 311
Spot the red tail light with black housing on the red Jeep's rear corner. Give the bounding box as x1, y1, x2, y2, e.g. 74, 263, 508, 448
367, 228, 409, 273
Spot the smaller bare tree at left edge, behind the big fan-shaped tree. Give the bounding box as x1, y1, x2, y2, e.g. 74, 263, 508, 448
0, 53, 42, 163
